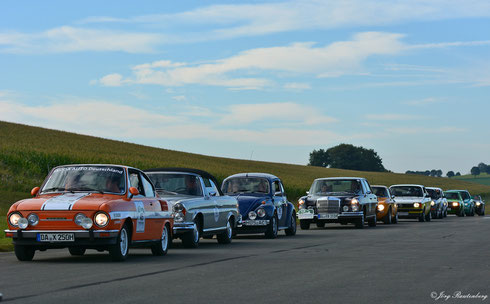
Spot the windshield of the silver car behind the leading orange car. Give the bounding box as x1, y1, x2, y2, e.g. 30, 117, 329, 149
147, 173, 203, 196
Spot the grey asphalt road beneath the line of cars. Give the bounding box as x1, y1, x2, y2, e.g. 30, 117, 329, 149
0, 216, 490, 303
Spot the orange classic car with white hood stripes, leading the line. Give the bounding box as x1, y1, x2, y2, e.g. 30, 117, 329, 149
5, 165, 173, 261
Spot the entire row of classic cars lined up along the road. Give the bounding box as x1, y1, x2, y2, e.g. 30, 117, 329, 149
5, 164, 485, 261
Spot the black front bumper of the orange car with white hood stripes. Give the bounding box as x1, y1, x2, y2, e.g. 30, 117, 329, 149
5, 229, 119, 248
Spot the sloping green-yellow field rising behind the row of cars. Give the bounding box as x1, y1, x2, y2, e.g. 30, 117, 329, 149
0, 121, 490, 250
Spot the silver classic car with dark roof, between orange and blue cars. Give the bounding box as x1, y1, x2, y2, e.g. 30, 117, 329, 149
145, 168, 241, 248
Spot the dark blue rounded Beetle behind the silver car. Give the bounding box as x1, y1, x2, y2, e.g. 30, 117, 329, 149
221, 173, 296, 238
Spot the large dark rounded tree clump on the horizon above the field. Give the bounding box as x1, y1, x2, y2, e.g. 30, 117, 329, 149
308, 144, 386, 172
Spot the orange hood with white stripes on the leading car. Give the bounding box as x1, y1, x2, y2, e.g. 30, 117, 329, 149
12, 192, 121, 211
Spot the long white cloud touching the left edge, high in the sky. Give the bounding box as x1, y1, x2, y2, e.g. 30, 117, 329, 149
0, 26, 164, 53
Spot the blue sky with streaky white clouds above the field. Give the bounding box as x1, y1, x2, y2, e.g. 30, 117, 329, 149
0, 0, 490, 174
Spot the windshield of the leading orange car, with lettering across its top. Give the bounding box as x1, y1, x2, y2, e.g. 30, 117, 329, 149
41, 166, 126, 194
